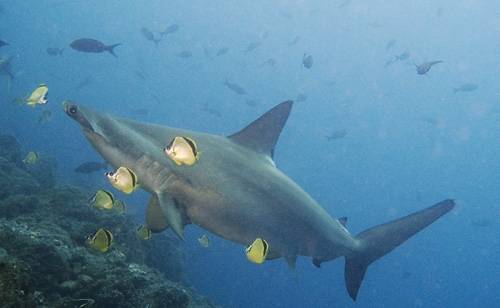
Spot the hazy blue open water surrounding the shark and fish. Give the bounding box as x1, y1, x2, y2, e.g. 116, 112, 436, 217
0, 0, 500, 307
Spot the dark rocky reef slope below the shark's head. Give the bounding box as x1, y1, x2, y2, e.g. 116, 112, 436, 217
0, 136, 214, 307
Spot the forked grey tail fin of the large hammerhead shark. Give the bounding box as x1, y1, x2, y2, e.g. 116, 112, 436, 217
344, 200, 455, 300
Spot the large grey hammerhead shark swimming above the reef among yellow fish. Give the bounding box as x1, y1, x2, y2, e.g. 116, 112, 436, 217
64, 101, 454, 300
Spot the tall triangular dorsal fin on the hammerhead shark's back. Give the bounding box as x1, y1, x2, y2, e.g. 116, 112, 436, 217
229, 101, 293, 158
